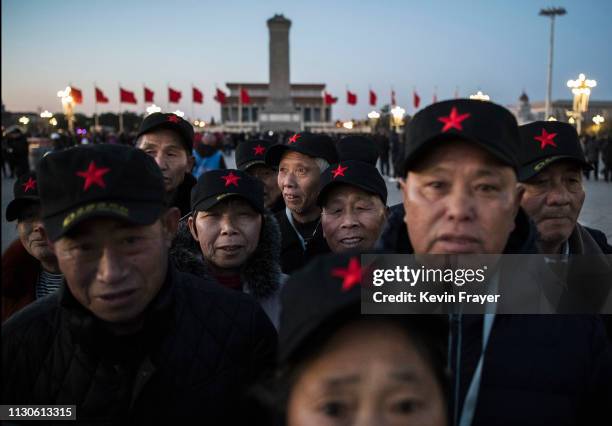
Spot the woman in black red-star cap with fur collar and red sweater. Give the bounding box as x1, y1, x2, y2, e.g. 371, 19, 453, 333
172, 169, 284, 328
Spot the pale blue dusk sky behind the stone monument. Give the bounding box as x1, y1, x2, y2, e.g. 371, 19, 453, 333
2, 0, 612, 120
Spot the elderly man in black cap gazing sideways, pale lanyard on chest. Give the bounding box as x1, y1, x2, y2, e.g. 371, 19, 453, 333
266, 132, 338, 274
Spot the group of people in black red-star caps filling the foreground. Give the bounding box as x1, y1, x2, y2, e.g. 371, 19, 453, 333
0, 99, 612, 426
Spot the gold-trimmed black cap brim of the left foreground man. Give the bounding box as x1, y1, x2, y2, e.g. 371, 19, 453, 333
43, 201, 163, 241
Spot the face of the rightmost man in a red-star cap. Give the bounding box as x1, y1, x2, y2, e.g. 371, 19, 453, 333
521, 160, 585, 251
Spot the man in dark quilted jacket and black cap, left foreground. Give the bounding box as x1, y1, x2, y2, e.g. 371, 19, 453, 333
1, 145, 276, 424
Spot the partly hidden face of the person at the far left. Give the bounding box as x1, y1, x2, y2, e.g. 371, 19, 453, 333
17, 202, 55, 262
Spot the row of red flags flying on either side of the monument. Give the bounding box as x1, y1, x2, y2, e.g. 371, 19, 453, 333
70, 86, 436, 108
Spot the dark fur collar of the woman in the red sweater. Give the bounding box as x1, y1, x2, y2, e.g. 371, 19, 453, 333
170, 213, 285, 328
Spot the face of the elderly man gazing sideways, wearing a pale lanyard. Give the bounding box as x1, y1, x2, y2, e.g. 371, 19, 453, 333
278, 151, 321, 215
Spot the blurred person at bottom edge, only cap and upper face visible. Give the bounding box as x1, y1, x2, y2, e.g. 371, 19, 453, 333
267, 254, 447, 426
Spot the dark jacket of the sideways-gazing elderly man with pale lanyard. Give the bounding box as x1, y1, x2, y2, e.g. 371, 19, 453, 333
274, 210, 331, 274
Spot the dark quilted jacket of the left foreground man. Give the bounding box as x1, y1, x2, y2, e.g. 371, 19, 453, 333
1, 267, 276, 424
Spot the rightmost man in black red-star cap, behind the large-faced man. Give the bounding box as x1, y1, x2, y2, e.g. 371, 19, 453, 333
519, 121, 612, 254
